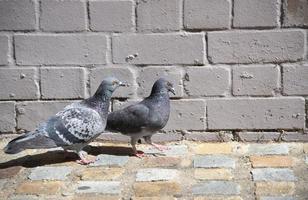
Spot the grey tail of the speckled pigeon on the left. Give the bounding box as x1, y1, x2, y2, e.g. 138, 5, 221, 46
4, 132, 57, 154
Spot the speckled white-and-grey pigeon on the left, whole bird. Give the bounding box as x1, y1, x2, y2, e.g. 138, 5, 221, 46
4, 77, 126, 164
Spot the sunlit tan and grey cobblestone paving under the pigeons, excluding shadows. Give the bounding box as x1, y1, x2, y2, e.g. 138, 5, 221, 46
0, 139, 308, 200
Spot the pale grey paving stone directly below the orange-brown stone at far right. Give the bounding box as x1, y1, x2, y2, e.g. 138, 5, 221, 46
251, 168, 296, 181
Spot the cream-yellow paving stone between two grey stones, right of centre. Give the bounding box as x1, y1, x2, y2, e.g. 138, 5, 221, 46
194, 168, 233, 180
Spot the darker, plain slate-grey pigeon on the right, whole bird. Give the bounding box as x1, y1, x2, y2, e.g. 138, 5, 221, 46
106, 78, 175, 157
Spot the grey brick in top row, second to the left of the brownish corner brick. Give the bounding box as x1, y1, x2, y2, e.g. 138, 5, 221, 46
184, 0, 231, 29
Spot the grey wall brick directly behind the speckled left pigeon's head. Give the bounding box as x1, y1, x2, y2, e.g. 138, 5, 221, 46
90, 66, 136, 97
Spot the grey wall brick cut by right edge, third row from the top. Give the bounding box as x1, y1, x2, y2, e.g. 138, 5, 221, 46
282, 63, 308, 95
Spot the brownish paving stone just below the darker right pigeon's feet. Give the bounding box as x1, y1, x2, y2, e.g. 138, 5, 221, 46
143, 157, 181, 167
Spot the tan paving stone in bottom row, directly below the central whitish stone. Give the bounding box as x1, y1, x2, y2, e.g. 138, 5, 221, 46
133, 181, 181, 197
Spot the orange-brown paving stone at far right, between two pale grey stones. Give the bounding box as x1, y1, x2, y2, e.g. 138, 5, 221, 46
250, 156, 293, 167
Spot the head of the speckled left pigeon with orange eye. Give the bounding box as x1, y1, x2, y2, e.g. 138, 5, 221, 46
94, 77, 127, 96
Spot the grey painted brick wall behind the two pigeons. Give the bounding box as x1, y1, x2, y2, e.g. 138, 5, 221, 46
0, 0, 308, 140
